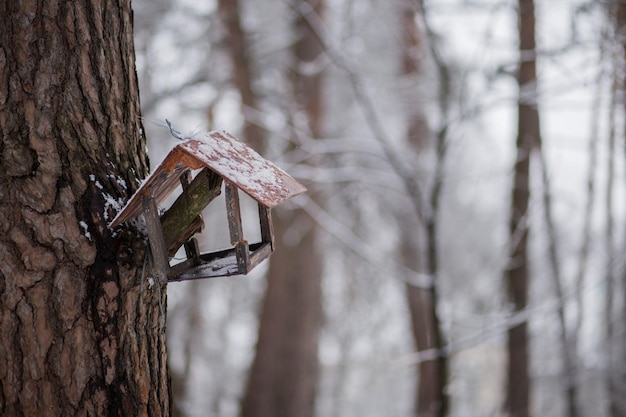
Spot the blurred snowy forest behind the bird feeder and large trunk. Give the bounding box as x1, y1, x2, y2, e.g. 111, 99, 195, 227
134, 0, 626, 417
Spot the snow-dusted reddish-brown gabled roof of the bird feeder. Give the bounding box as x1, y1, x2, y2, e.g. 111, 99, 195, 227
109, 131, 306, 228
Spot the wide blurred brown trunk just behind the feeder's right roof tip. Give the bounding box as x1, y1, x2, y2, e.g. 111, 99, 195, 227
241, 0, 324, 417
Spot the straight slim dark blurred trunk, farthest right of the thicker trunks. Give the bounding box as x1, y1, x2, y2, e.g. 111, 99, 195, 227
505, 0, 539, 417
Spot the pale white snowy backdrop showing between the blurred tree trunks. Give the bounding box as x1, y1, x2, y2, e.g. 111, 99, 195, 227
134, 0, 625, 417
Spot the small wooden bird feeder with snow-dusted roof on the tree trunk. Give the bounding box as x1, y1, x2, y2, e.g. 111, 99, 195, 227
109, 131, 306, 282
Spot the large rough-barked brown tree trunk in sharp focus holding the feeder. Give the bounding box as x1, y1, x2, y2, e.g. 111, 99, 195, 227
0, 0, 169, 416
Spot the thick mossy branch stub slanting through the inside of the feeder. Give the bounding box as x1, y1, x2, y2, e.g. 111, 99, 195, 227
161, 168, 222, 253
